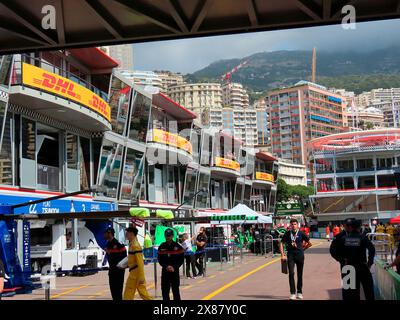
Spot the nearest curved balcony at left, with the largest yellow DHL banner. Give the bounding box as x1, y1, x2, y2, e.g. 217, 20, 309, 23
10, 55, 111, 132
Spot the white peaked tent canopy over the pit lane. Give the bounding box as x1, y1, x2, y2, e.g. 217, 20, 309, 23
211, 203, 272, 224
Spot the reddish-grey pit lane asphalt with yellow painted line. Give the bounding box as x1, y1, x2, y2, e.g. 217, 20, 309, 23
3, 239, 341, 300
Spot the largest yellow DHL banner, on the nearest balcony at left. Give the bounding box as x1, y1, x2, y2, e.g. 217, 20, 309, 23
22, 63, 111, 121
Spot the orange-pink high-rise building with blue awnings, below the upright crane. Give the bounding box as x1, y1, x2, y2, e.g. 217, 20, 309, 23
269, 81, 346, 164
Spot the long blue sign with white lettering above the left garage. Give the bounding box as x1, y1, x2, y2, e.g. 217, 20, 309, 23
0, 194, 117, 214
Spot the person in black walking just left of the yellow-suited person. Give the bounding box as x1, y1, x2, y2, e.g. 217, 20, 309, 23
104, 228, 126, 301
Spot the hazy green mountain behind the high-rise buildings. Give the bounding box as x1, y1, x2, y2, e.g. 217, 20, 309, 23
186, 47, 400, 98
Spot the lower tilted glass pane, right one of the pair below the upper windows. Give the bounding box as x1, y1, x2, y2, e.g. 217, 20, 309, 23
121, 148, 144, 201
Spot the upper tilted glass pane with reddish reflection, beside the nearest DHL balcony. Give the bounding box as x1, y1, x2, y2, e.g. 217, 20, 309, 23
109, 76, 132, 135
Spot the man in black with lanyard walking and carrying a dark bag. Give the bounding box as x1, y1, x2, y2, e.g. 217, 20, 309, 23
279, 219, 312, 300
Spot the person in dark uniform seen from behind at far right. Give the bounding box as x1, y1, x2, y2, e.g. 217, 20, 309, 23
330, 218, 375, 300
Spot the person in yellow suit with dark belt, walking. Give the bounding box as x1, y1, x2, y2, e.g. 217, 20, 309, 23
124, 227, 153, 300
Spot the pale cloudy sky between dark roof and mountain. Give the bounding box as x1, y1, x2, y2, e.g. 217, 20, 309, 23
133, 19, 400, 74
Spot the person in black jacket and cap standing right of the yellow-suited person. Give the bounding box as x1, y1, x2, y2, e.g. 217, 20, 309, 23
158, 229, 184, 301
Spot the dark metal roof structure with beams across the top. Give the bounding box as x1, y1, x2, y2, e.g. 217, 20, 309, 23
0, 0, 400, 54
